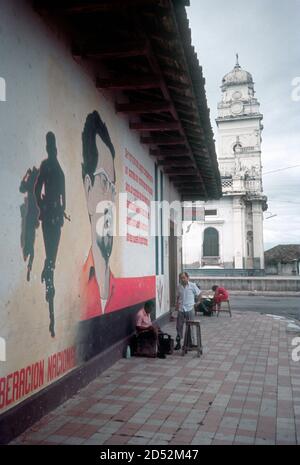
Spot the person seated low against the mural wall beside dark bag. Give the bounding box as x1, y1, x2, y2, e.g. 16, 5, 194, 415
136, 300, 166, 358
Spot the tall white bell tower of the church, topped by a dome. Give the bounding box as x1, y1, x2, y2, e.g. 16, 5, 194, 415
216, 55, 267, 269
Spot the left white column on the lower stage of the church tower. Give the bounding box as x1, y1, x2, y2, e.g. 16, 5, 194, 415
233, 197, 245, 268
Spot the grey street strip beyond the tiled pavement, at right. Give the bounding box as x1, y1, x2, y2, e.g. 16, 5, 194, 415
230, 295, 300, 321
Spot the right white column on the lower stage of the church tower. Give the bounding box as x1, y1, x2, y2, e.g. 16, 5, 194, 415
252, 201, 265, 269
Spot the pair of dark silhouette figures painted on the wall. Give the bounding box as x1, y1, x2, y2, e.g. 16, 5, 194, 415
20, 132, 70, 337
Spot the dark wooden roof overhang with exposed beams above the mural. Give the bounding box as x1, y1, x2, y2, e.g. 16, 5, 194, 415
34, 0, 222, 200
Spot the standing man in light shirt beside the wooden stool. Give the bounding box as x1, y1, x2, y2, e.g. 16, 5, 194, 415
175, 272, 201, 350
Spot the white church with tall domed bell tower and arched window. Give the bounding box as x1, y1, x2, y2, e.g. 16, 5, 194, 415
183, 57, 267, 274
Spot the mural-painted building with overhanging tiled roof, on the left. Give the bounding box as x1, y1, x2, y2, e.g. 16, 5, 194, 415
0, 0, 221, 443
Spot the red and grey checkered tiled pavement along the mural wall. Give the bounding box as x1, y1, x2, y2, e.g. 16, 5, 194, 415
8, 312, 300, 445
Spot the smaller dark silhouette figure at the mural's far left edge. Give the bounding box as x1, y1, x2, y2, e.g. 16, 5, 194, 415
19, 166, 39, 281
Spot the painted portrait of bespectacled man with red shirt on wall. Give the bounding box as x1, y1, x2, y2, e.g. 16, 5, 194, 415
80, 111, 155, 320
